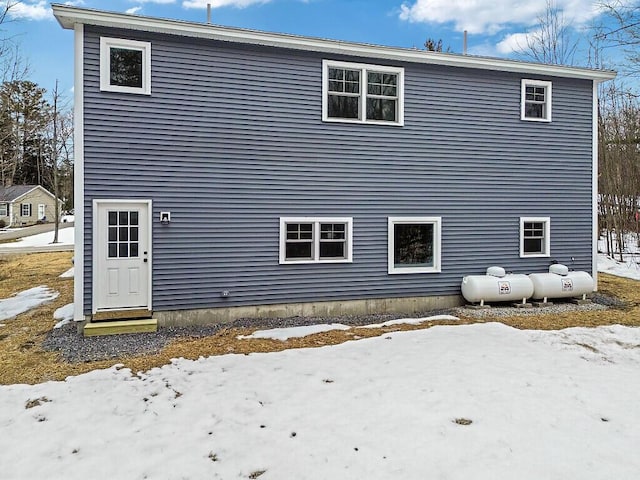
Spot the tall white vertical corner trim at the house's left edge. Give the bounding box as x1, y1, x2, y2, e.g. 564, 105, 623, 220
73, 24, 85, 322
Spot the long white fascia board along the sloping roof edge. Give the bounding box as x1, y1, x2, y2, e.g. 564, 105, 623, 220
52, 4, 616, 82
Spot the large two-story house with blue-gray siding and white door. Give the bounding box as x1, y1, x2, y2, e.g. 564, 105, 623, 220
53, 5, 615, 330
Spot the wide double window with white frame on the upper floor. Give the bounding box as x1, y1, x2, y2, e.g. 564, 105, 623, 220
322, 60, 404, 125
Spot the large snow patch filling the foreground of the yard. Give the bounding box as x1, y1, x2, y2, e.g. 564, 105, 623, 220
0, 323, 640, 480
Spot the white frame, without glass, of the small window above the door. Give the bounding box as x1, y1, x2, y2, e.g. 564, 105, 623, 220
100, 37, 151, 95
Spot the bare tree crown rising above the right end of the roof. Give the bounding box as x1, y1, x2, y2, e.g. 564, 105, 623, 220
516, 0, 578, 65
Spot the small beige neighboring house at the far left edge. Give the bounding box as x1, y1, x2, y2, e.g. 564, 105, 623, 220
0, 185, 62, 227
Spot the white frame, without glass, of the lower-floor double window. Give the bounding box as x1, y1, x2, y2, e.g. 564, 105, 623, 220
279, 217, 353, 265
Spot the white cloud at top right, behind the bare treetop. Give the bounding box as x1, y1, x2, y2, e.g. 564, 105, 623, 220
400, 0, 601, 35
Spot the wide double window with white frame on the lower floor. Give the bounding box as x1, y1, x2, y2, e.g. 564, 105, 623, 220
280, 217, 353, 264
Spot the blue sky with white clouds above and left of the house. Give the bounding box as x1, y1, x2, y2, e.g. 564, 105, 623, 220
0, 0, 632, 95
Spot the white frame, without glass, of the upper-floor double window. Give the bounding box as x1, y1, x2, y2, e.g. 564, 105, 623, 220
322, 59, 404, 127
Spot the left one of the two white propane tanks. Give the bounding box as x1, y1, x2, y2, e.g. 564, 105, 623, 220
461, 267, 533, 305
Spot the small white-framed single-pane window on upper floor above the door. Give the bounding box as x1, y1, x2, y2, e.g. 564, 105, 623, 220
100, 37, 151, 95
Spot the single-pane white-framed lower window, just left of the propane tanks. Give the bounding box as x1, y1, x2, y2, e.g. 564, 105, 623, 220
388, 217, 442, 273
